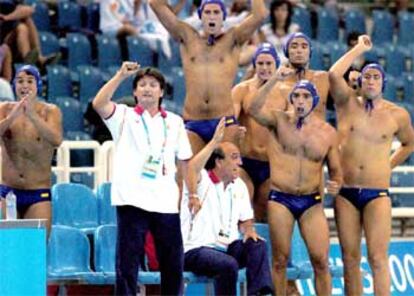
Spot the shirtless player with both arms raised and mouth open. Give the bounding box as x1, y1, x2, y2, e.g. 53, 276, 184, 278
150, 0, 267, 154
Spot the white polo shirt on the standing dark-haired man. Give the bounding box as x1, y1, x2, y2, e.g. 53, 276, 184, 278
104, 104, 192, 213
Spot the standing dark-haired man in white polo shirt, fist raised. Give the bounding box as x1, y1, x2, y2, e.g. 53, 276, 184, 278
93, 62, 192, 295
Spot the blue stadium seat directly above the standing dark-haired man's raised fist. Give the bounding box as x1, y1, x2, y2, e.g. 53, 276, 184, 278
127, 36, 155, 67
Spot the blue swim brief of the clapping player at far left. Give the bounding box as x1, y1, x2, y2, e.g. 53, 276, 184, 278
0, 185, 52, 216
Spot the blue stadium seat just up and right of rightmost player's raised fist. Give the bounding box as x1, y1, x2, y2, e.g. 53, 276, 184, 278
372, 10, 394, 45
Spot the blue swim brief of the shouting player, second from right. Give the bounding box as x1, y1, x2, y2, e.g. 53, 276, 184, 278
269, 190, 322, 220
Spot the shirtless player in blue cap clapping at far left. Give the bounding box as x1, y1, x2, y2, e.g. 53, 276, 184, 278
0, 65, 62, 234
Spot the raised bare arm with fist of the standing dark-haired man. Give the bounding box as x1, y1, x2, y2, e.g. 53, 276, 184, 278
92, 62, 139, 118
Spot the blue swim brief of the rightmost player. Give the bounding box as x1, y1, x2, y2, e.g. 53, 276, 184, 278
339, 187, 389, 211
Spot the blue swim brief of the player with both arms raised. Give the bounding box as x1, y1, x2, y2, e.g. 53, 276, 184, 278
184, 116, 239, 143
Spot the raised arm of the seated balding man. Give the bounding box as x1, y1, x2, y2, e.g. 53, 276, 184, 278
186, 117, 226, 214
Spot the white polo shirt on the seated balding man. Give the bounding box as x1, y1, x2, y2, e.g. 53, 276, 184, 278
180, 170, 254, 252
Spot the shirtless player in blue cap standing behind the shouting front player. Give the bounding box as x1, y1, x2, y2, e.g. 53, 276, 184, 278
277, 32, 329, 120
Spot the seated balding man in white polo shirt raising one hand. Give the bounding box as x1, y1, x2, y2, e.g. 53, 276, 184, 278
180, 118, 273, 295
